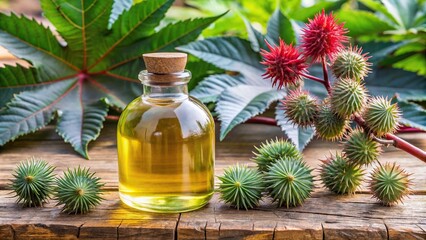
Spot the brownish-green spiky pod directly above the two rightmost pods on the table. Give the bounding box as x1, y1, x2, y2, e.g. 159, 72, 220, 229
343, 128, 382, 165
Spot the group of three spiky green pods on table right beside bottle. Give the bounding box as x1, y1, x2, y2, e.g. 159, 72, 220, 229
218, 142, 314, 209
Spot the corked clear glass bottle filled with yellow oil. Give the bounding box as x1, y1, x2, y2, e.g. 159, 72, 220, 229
117, 53, 215, 212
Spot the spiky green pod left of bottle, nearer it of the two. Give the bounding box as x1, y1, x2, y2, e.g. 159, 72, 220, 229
55, 166, 104, 214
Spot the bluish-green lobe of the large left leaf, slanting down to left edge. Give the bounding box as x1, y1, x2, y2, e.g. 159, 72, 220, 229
0, 80, 76, 145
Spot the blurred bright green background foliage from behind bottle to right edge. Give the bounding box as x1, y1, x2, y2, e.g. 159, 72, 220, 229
168, 0, 426, 76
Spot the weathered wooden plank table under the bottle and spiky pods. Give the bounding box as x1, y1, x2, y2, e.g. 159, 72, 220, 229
0, 122, 426, 239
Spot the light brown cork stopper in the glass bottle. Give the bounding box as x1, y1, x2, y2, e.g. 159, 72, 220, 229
142, 52, 187, 74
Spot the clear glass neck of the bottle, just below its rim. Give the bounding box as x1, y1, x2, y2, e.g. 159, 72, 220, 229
142, 83, 188, 101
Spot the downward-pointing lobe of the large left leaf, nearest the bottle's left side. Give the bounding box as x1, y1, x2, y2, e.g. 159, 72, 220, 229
56, 98, 108, 159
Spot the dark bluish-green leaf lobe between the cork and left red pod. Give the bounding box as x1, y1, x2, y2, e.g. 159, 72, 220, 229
177, 37, 262, 78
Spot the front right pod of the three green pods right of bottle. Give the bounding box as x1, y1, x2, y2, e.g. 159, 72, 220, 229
265, 159, 314, 208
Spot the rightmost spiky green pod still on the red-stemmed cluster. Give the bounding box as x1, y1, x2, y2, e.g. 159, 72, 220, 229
364, 97, 400, 136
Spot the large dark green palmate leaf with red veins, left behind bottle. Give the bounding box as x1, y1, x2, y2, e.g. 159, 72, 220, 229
0, 0, 220, 158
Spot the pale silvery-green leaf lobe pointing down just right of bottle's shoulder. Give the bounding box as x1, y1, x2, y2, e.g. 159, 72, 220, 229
216, 85, 284, 141
